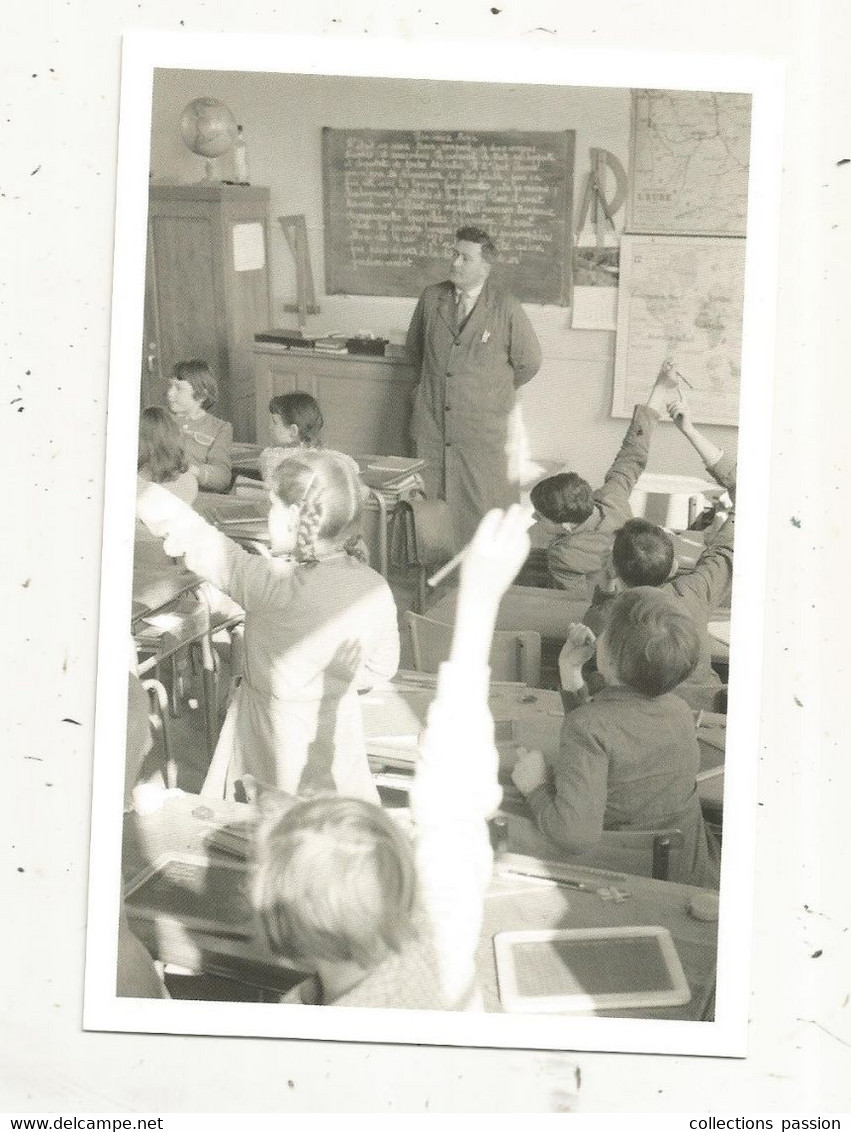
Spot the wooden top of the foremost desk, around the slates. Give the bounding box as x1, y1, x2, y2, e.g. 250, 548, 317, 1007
123, 795, 716, 1019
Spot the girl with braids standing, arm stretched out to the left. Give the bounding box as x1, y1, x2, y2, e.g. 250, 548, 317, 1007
137, 451, 399, 800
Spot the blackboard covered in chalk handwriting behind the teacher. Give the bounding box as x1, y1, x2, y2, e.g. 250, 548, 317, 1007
323, 127, 576, 306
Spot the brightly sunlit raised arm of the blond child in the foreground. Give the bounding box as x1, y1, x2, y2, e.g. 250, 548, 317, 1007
411, 507, 528, 1005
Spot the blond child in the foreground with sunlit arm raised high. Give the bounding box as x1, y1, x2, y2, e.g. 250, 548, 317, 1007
248, 507, 528, 1010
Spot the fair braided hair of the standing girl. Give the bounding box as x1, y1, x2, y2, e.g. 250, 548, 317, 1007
274, 448, 366, 564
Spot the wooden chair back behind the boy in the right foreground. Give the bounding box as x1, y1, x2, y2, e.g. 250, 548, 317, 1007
507, 814, 684, 881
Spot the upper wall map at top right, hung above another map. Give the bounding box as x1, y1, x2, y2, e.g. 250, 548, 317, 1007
627, 89, 751, 235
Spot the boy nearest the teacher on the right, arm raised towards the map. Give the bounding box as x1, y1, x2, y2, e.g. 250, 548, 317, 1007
531, 361, 678, 601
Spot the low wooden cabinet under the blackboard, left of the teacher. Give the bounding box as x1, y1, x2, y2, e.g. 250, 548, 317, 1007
255, 343, 416, 456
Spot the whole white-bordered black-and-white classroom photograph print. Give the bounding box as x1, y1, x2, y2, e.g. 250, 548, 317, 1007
86, 37, 776, 1055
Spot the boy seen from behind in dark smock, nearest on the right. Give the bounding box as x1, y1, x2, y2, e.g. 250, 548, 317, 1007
512, 586, 717, 887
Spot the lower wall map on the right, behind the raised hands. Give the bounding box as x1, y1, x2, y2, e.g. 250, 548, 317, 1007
612, 235, 746, 425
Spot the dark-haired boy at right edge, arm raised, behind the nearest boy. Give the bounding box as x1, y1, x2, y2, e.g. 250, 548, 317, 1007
585, 397, 736, 709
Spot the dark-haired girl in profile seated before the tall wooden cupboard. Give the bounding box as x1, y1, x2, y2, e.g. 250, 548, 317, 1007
166, 360, 233, 491
